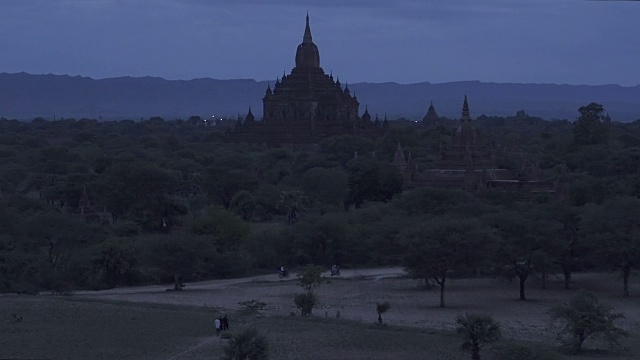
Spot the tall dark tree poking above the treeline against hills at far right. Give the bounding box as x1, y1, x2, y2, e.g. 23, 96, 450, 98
573, 102, 609, 145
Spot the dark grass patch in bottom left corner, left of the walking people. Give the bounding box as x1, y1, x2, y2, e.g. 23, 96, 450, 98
0, 296, 214, 360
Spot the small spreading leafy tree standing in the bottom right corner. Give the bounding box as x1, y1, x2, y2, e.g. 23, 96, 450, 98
550, 291, 628, 353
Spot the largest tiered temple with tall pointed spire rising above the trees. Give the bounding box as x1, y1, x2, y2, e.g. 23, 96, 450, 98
234, 15, 382, 145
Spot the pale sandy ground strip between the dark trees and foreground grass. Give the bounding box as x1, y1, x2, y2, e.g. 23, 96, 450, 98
67, 267, 640, 342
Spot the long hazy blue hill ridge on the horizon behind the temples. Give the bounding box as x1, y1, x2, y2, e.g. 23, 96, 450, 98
0, 73, 640, 122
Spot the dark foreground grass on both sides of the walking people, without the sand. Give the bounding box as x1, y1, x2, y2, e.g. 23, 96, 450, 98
0, 296, 466, 360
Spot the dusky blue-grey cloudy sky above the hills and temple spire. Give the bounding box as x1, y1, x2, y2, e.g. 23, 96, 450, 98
0, 0, 640, 86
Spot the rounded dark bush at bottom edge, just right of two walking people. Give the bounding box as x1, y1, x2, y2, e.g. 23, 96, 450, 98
222, 329, 269, 360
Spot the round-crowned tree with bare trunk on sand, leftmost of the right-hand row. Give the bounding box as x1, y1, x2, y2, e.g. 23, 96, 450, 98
403, 217, 493, 307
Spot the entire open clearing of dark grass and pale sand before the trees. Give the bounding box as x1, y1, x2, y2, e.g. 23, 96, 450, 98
0, 269, 640, 360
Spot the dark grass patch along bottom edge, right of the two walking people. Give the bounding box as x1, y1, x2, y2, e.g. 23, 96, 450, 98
229, 310, 468, 360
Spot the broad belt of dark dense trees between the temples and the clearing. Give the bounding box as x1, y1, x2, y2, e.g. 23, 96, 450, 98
0, 103, 640, 296
